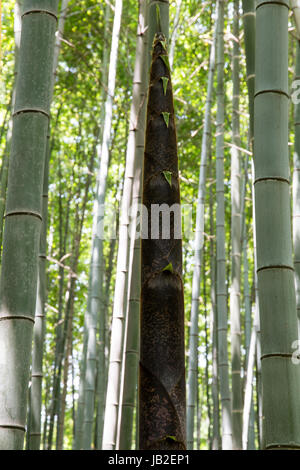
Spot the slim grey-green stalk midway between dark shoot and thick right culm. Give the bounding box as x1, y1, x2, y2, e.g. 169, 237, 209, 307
216, 0, 232, 450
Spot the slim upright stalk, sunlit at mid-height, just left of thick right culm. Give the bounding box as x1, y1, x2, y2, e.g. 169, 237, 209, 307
230, 0, 243, 450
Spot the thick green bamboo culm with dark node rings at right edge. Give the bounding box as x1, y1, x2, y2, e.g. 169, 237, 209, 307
254, 0, 300, 449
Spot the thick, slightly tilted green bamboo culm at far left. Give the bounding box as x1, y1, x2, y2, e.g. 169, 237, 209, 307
0, 0, 58, 450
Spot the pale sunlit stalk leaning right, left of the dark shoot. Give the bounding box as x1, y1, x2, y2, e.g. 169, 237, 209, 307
104, 0, 146, 448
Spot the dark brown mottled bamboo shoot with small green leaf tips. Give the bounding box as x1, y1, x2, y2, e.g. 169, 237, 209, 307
139, 33, 186, 450
